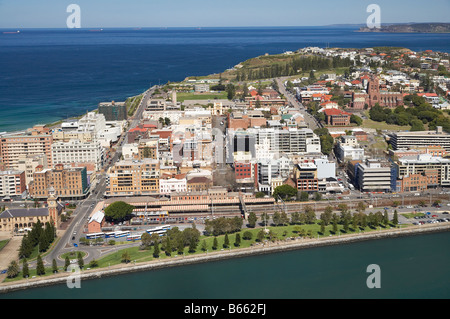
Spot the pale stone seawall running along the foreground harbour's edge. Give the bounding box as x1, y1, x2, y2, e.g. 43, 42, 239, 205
0, 224, 450, 294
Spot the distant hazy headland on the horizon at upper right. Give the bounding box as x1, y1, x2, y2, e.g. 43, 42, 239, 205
359, 23, 450, 33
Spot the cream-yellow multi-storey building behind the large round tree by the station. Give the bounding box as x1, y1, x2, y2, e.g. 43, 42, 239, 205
106, 158, 160, 196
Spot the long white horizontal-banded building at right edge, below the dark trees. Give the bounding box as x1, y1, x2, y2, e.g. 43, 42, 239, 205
390, 126, 450, 152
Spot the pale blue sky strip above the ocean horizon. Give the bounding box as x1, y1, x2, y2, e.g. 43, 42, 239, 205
0, 0, 450, 28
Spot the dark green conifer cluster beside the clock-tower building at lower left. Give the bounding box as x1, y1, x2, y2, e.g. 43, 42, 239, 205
19, 220, 56, 258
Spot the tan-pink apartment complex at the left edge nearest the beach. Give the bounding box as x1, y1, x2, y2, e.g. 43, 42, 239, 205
0, 125, 53, 170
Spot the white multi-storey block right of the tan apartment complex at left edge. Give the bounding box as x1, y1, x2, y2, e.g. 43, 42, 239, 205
51, 140, 104, 170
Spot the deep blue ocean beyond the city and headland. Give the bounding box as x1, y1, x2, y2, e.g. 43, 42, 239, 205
0, 27, 450, 132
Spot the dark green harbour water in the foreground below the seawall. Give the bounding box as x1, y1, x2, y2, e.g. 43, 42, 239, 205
0, 232, 450, 298
